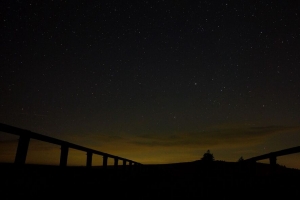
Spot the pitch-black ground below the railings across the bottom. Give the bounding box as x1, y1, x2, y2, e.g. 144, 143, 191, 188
0, 162, 300, 200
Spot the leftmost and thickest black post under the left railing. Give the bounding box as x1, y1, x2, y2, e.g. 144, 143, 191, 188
15, 135, 30, 165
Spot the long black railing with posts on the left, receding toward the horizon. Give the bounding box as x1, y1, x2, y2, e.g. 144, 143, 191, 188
0, 123, 142, 168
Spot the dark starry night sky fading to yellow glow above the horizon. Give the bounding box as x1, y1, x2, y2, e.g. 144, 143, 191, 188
0, 0, 300, 168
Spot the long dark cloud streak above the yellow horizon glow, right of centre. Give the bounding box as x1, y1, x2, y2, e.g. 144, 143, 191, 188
130, 126, 300, 148
